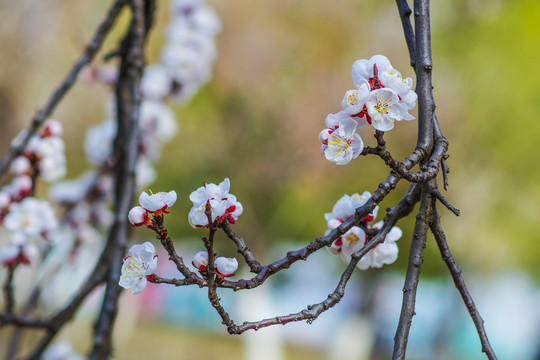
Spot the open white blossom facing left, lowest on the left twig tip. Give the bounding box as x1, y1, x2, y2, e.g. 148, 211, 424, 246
118, 241, 157, 295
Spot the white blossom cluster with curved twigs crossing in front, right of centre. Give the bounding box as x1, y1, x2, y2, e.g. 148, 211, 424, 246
324, 191, 402, 270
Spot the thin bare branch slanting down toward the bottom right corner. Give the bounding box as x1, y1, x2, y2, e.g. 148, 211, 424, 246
431, 214, 497, 360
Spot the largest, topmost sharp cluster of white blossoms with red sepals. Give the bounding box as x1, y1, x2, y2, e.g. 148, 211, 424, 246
319, 55, 417, 165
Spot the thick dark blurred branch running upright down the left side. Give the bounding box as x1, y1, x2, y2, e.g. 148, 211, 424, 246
88, 0, 147, 359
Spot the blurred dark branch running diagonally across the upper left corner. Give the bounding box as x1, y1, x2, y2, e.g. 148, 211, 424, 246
0, 0, 125, 176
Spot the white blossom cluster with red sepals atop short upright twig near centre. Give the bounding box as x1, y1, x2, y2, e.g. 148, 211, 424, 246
188, 178, 244, 228
